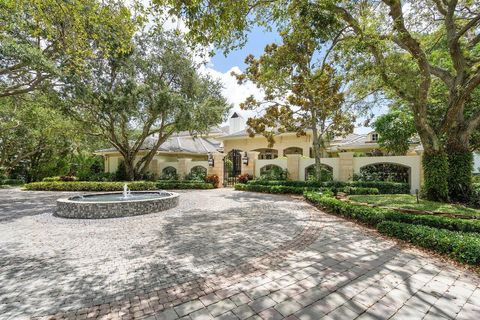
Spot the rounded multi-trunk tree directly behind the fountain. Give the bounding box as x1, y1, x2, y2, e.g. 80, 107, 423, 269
69, 29, 228, 180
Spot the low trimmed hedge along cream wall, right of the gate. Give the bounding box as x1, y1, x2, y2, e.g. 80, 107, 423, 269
235, 183, 378, 196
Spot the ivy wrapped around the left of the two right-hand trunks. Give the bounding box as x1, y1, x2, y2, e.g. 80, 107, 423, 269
422, 152, 448, 202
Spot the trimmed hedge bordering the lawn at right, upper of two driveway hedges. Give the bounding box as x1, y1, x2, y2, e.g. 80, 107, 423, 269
304, 192, 480, 233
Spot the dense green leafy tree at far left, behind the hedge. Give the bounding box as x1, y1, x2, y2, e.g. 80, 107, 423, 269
0, 93, 95, 181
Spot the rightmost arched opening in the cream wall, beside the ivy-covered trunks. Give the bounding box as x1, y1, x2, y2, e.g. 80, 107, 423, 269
354, 163, 410, 183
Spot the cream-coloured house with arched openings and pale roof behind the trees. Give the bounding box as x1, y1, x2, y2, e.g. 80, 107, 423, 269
96, 112, 422, 193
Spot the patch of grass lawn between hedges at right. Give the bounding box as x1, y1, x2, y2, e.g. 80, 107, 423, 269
349, 194, 480, 216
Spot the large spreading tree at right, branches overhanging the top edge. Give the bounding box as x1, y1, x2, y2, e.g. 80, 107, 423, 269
159, 0, 480, 200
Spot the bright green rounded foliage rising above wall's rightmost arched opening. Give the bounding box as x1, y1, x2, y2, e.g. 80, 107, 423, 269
373, 109, 416, 155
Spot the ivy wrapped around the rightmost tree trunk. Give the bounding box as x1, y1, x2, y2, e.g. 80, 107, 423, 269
448, 151, 473, 203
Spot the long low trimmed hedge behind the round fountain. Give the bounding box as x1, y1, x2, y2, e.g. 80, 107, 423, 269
24, 181, 213, 191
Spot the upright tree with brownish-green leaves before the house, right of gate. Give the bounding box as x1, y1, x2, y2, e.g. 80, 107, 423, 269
234, 8, 354, 181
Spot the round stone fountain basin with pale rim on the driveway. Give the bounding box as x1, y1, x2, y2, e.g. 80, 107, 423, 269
55, 191, 179, 219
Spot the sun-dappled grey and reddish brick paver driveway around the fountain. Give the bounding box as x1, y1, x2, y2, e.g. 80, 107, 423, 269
0, 189, 480, 320
